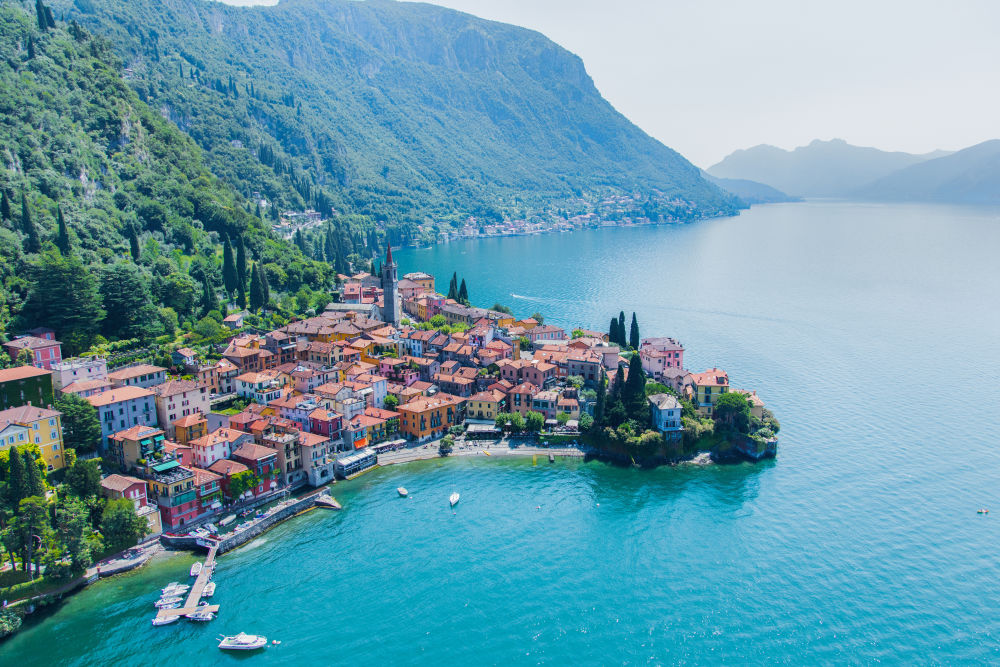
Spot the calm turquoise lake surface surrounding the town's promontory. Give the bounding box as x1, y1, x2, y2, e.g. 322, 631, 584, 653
7, 203, 1000, 667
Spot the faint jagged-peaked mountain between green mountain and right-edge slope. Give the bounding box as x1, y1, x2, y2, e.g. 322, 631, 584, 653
706, 139, 943, 197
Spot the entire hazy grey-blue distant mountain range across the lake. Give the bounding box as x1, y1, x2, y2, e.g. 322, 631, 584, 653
706, 139, 1000, 204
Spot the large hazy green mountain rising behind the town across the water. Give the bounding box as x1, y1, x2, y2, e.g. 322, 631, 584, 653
53, 0, 740, 235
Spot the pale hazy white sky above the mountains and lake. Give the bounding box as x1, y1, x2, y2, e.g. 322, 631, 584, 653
221, 0, 1000, 167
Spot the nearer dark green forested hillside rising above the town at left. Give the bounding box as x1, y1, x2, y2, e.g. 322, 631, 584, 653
0, 4, 344, 353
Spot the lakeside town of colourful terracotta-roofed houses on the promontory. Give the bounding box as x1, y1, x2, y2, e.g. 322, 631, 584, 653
0, 248, 778, 636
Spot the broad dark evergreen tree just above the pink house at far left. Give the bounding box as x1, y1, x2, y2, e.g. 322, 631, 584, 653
19, 245, 104, 354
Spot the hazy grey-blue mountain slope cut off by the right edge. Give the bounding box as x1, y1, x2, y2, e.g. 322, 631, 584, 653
857, 139, 1000, 204
